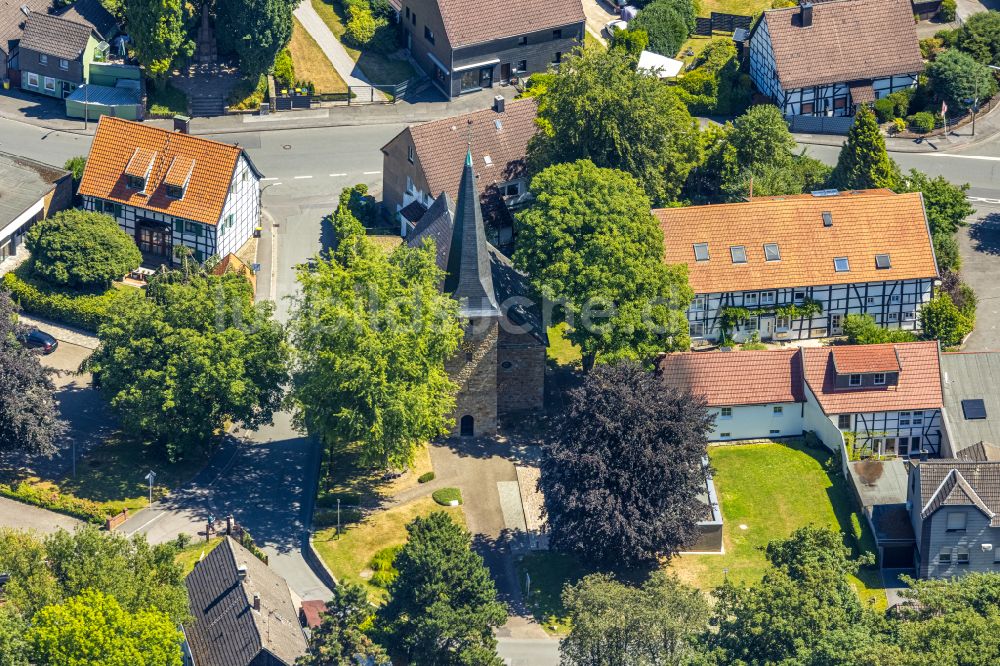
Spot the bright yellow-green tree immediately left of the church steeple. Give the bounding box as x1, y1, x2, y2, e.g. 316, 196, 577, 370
289, 195, 462, 467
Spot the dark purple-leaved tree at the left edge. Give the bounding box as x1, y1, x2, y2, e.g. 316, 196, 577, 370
0, 291, 67, 455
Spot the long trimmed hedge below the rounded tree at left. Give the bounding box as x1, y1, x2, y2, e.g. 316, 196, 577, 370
3, 269, 141, 332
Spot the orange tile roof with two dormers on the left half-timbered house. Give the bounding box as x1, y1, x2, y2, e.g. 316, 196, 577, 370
79, 116, 252, 224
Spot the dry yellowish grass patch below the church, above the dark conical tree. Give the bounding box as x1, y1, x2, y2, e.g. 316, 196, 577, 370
313, 497, 465, 602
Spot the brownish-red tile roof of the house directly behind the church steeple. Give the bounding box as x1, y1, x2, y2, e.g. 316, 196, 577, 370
392, 98, 538, 201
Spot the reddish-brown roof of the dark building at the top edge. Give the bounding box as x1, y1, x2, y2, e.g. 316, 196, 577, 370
437, 0, 592, 48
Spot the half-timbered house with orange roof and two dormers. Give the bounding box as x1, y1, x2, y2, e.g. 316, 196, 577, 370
79, 116, 261, 263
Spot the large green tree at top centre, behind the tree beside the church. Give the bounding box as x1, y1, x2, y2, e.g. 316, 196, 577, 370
528, 49, 700, 205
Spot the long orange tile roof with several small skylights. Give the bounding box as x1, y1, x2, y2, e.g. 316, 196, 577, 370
653, 190, 938, 294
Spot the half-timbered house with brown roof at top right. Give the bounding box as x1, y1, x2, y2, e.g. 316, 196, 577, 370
749, 0, 924, 116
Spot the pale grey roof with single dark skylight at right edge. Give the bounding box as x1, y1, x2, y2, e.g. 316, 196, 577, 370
941, 352, 1000, 456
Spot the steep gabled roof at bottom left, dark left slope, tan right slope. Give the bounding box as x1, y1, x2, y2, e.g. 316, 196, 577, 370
184, 536, 307, 666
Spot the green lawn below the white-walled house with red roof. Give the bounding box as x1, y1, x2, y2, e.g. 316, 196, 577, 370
669, 443, 886, 608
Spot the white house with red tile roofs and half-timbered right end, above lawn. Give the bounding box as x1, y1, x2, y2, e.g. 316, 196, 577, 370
659, 342, 943, 457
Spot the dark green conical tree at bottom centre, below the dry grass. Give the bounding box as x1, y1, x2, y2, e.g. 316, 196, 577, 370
376, 511, 507, 666
